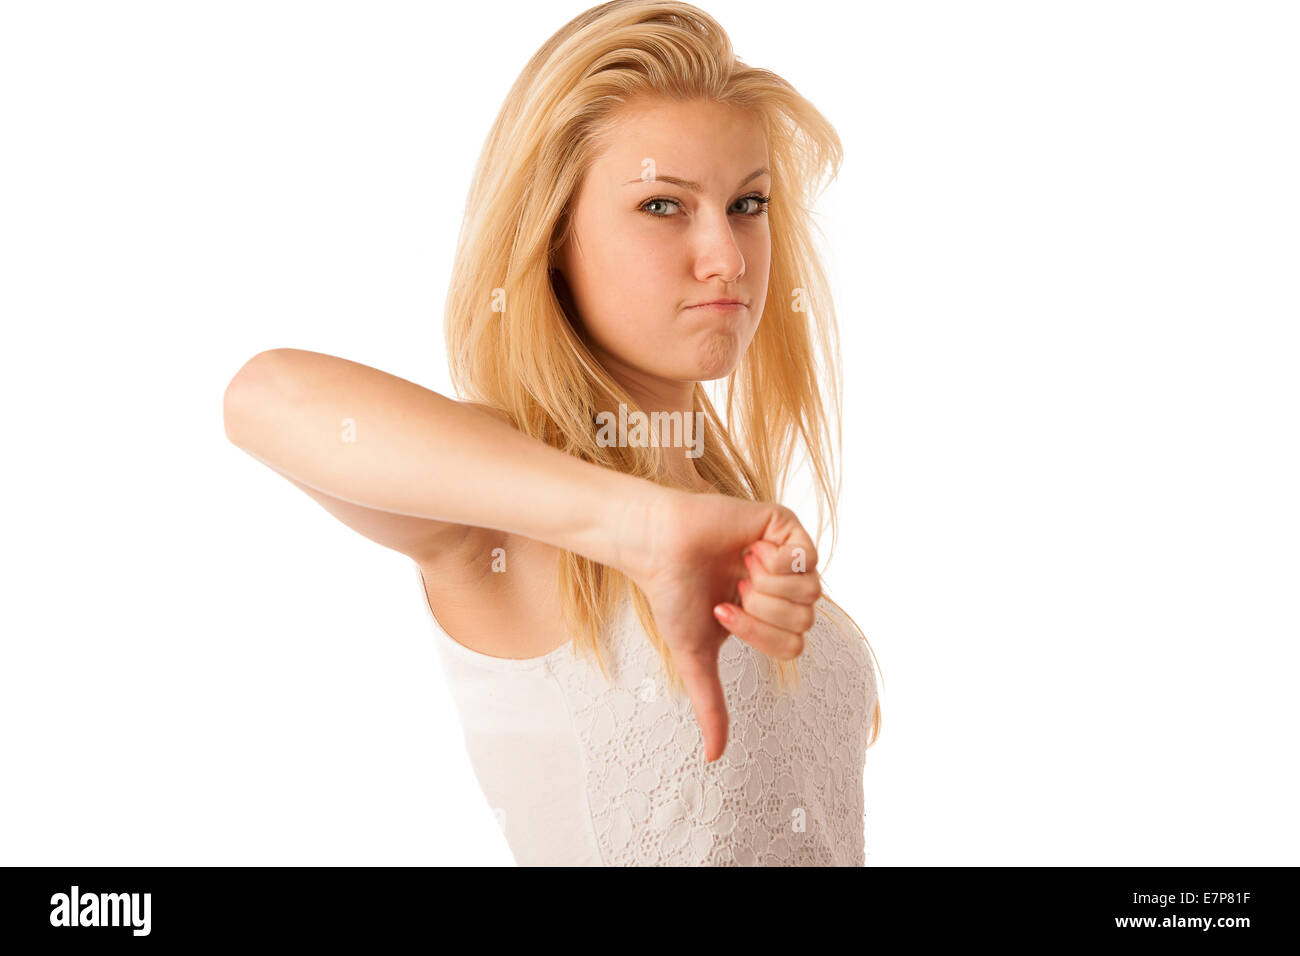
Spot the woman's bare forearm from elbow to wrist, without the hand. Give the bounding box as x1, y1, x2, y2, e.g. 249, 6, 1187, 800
225, 350, 667, 567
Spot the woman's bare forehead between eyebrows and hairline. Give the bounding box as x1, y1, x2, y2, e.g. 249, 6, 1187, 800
592, 100, 767, 184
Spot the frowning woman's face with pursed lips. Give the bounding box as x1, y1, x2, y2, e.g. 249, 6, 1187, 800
555, 100, 772, 390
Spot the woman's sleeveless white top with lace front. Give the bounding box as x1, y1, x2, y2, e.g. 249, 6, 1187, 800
416, 567, 876, 866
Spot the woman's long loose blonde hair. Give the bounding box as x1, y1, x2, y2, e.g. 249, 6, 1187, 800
446, 0, 880, 743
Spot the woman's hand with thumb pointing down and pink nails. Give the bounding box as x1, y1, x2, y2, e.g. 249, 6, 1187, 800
619, 489, 822, 762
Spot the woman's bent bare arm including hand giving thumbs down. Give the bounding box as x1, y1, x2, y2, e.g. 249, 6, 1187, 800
225, 349, 820, 761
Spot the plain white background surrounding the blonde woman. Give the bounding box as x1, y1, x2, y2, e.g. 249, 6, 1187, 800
0, 0, 1300, 865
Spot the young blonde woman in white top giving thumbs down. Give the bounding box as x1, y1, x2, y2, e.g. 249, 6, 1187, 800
225, 0, 880, 865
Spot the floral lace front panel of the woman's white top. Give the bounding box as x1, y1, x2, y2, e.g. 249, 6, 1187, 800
547, 601, 876, 866
